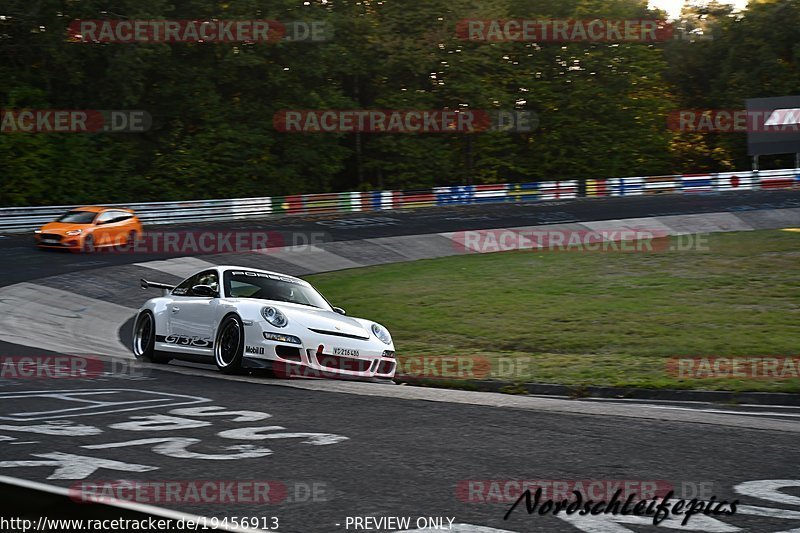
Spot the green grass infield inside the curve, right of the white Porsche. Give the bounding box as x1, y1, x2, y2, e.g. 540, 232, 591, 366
309, 230, 800, 392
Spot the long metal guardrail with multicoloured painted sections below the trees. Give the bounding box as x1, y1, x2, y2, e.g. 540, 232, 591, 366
0, 169, 800, 233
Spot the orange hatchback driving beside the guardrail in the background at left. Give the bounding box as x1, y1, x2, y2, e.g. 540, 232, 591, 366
34, 206, 142, 252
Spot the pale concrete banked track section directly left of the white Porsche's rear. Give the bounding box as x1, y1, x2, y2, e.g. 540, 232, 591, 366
0, 283, 135, 358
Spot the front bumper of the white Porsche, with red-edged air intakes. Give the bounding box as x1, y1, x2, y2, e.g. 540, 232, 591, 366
243, 325, 397, 380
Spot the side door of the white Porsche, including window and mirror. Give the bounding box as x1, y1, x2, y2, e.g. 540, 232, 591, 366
167, 270, 219, 355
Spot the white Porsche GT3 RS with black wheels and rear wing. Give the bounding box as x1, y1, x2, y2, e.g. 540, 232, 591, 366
133, 266, 396, 381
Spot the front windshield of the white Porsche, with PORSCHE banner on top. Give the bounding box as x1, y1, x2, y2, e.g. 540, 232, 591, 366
224, 270, 332, 311
